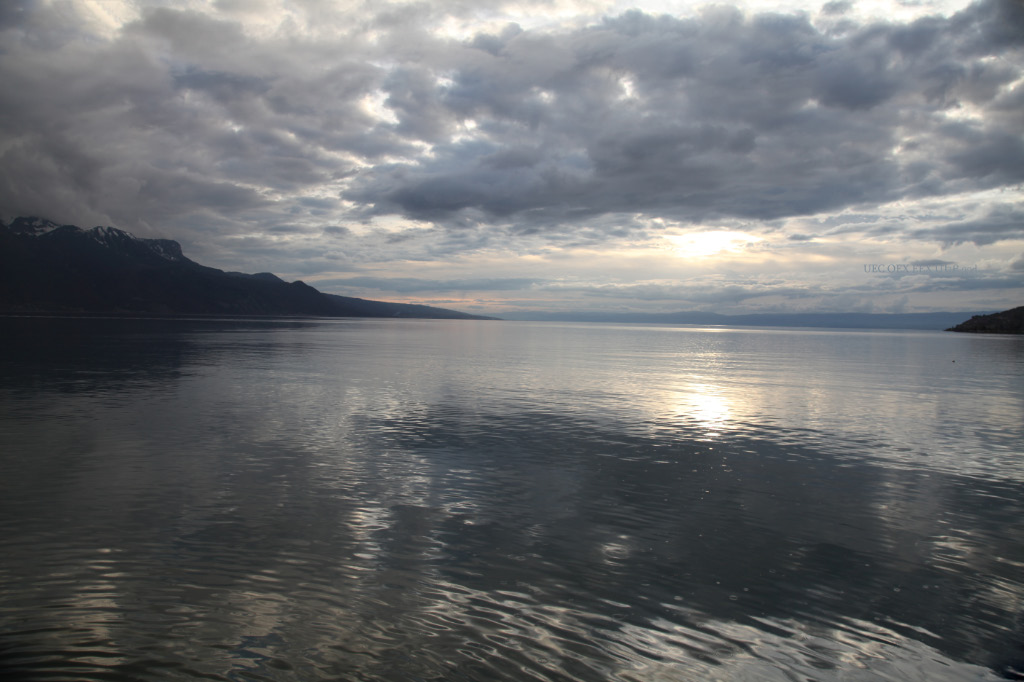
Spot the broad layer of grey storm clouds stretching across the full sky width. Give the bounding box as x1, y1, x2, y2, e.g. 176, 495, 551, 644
0, 0, 1024, 254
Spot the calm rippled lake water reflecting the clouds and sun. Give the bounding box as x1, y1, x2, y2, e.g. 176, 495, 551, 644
0, 318, 1024, 682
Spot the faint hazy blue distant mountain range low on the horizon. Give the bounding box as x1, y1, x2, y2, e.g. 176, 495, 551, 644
502, 311, 995, 331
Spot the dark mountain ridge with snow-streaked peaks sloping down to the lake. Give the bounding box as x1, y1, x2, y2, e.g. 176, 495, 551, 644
0, 217, 491, 319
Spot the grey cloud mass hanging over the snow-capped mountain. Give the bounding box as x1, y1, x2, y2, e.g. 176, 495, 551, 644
0, 1, 376, 235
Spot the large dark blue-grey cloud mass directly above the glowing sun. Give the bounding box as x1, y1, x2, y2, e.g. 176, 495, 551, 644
349, 1, 1024, 233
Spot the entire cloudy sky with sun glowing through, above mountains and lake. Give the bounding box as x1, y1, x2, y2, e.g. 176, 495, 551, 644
0, 0, 1024, 315
